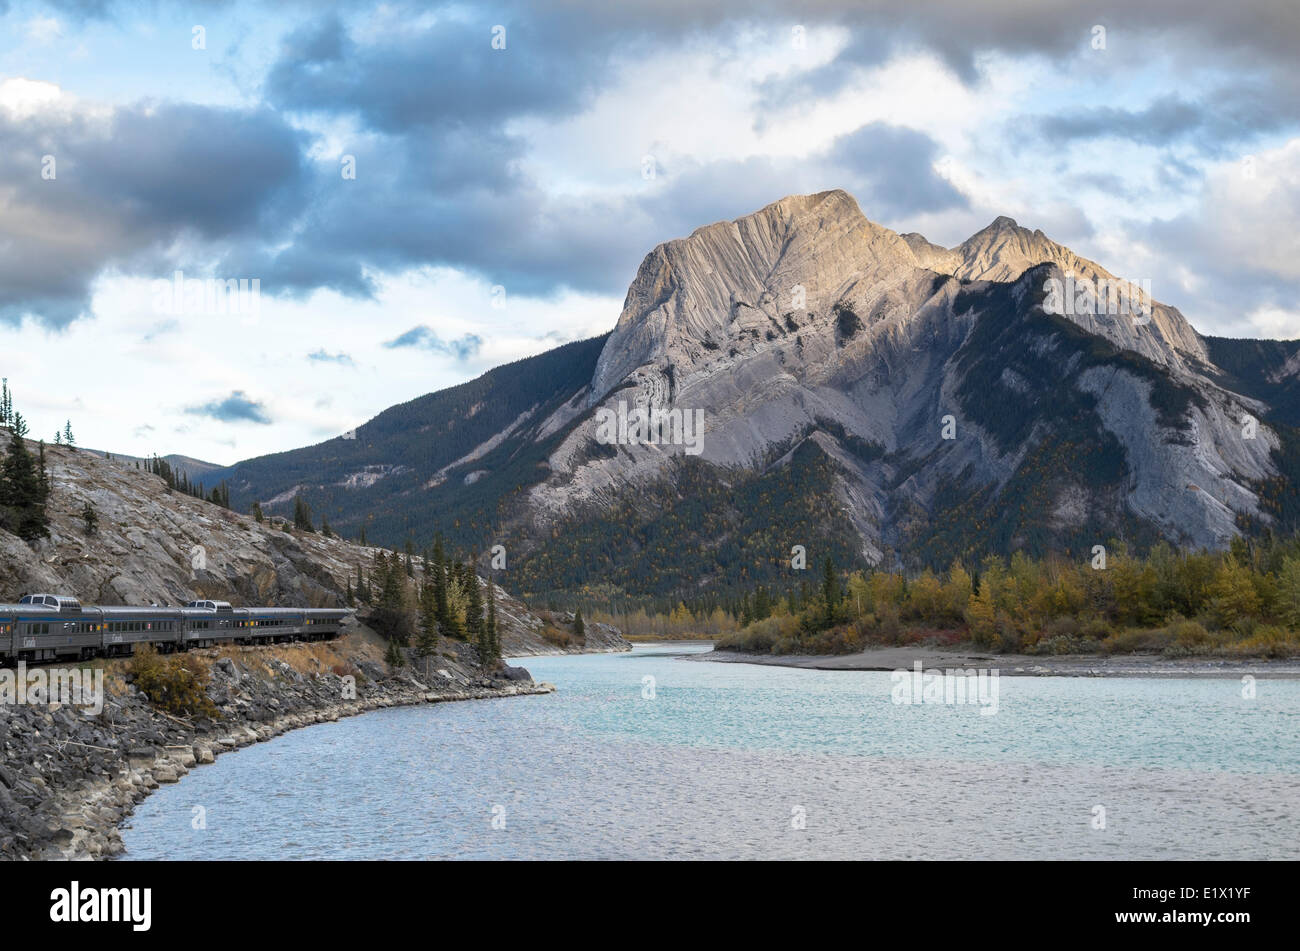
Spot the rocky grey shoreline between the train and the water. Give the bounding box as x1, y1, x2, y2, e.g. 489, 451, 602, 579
0, 634, 554, 860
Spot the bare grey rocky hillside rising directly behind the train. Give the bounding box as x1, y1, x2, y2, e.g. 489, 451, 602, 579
0, 446, 627, 655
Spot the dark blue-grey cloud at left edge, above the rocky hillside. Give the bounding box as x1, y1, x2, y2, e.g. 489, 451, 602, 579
0, 104, 304, 327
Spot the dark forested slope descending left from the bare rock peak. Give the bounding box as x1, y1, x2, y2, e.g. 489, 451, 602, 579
205, 336, 606, 547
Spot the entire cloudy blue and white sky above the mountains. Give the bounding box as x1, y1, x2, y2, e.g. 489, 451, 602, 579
0, 0, 1300, 463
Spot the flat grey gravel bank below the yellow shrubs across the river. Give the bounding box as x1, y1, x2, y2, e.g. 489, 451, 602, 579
688, 646, 1300, 679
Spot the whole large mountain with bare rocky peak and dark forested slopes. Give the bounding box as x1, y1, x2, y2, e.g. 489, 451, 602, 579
209, 191, 1300, 600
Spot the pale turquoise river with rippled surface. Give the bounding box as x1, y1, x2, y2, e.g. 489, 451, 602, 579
122, 644, 1300, 860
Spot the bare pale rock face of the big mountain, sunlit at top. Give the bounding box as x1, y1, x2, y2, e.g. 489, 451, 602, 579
509, 191, 1278, 559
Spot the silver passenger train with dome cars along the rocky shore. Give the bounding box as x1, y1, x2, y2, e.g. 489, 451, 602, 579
0, 594, 352, 664
